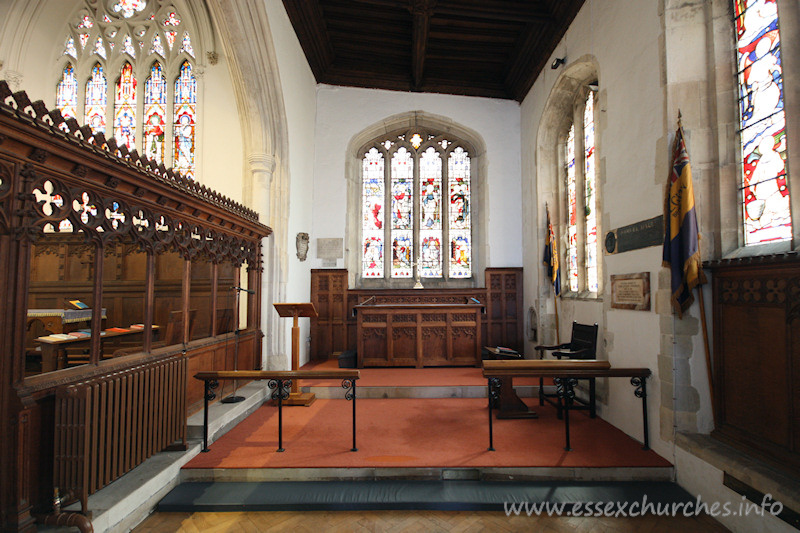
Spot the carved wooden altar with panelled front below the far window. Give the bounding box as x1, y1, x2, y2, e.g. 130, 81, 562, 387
354, 303, 483, 368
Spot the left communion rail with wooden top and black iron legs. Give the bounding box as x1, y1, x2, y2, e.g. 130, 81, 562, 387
194, 369, 361, 452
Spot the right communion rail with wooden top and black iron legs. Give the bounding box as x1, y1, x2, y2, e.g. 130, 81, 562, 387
483, 359, 651, 451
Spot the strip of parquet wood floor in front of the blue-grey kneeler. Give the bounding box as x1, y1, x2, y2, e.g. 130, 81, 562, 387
133, 511, 728, 533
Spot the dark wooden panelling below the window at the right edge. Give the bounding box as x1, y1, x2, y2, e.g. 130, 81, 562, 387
708, 254, 800, 471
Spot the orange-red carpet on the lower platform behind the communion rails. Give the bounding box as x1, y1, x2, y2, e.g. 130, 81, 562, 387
184, 396, 670, 468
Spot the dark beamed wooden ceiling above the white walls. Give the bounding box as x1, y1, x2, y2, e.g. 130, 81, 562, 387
283, 0, 584, 101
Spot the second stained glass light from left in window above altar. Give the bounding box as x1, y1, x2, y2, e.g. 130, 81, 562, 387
391, 147, 414, 278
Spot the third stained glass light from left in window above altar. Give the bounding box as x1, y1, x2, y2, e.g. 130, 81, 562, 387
417, 147, 442, 278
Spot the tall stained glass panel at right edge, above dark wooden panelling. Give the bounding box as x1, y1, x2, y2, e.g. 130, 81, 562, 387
733, 0, 792, 245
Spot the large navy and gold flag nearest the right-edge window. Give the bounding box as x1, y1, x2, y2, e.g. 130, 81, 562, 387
662, 127, 706, 318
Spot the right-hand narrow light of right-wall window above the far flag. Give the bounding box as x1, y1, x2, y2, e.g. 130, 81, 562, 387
583, 91, 598, 292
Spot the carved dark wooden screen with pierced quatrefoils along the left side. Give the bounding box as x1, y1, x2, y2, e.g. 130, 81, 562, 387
0, 81, 271, 530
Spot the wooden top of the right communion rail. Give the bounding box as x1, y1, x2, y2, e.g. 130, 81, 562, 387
483, 359, 650, 378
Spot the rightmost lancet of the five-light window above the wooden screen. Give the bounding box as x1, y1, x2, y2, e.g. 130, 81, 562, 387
172, 61, 197, 178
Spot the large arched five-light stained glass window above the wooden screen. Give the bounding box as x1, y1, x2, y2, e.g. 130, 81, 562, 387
54, 0, 198, 178
